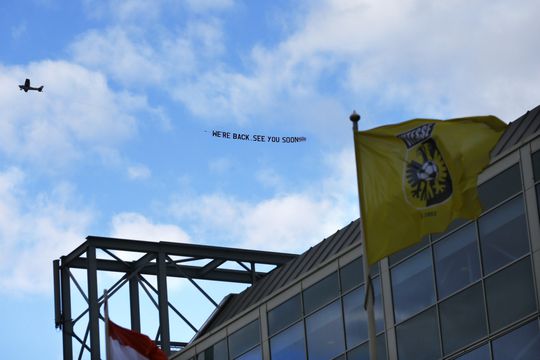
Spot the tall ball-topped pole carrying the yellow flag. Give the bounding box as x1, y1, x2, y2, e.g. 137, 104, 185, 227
349, 111, 377, 360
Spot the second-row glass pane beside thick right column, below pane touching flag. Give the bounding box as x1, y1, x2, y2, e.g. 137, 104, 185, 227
478, 196, 529, 274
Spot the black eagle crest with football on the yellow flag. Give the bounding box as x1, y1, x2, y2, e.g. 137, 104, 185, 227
397, 123, 452, 209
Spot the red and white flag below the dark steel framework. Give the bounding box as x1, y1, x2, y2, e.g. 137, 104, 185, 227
107, 319, 168, 360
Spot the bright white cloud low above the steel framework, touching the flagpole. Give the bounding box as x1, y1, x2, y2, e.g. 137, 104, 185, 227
170, 149, 358, 252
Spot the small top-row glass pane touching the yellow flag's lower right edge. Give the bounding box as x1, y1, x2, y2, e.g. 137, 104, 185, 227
478, 164, 521, 210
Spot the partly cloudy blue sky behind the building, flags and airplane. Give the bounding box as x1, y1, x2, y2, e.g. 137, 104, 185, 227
0, 0, 540, 359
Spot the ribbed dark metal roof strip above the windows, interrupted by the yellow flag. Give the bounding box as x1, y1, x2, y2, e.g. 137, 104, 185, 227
193, 106, 540, 340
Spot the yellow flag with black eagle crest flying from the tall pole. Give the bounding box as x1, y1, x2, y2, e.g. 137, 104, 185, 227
354, 116, 506, 264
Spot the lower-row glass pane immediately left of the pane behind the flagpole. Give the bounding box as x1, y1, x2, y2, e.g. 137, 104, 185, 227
306, 301, 345, 360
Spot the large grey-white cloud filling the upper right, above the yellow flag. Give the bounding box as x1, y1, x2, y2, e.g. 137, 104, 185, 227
170, 0, 540, 122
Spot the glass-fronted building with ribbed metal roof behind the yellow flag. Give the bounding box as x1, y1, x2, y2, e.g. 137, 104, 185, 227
172, 107, 540, 360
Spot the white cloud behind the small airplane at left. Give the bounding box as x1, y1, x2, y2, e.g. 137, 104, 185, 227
0, 61, 148, 168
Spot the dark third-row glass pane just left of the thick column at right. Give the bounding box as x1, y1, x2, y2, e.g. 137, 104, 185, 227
485, 257, 536, 331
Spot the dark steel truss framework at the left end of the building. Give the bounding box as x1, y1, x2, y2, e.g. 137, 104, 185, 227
53, 236, 297, 360
